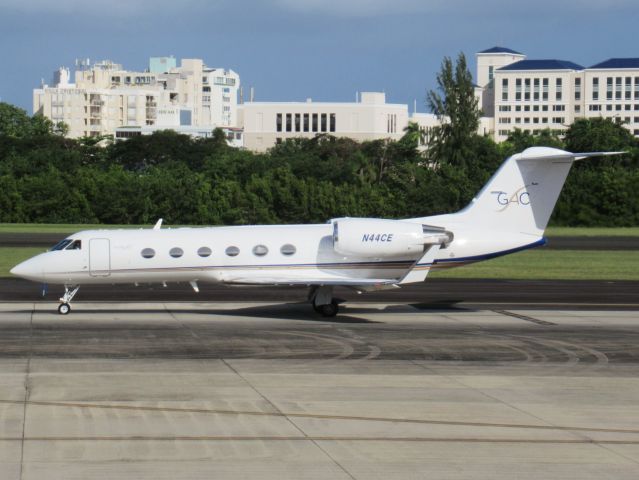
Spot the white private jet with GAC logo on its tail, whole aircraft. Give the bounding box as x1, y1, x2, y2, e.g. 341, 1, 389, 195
11, 147, 623, 317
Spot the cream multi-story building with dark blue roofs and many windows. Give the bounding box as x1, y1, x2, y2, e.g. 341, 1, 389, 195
477, 47, 639, 142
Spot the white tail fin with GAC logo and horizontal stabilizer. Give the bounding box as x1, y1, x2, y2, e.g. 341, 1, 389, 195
459, 147, 623, 235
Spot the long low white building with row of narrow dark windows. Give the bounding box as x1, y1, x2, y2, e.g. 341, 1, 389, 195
238, 92, 408, 151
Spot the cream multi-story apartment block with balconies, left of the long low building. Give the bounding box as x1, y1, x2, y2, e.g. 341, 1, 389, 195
33, 57, 240, 138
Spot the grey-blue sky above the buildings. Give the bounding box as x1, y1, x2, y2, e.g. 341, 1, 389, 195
0, 0, 639, 113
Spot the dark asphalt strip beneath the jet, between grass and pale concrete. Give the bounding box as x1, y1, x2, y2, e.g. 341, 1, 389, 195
0, 278, 639, 310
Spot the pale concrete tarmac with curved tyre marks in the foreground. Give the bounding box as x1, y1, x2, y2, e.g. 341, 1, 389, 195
0, 301, 639, 480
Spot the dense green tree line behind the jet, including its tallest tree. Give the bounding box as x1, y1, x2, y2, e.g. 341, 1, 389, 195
0, 56, 639, 226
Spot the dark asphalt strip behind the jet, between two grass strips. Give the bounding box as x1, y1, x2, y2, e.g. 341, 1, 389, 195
0, 233, 639, 250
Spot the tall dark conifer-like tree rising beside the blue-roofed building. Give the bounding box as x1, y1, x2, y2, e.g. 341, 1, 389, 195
426, 53, 481, 166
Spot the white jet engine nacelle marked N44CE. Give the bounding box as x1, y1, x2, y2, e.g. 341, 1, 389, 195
332, 218, 430, 257
